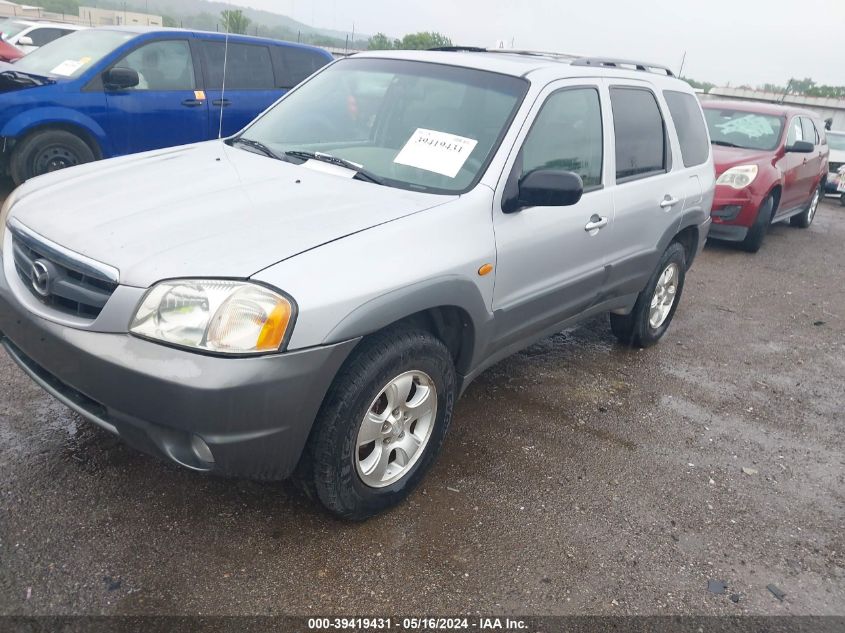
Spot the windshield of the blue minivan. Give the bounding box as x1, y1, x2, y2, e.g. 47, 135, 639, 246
15, 29, 137, 78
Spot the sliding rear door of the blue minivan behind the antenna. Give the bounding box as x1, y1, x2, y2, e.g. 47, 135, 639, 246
200, 40, 278, 138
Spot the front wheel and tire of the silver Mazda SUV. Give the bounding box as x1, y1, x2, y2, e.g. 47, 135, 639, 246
296, 329, 457, 521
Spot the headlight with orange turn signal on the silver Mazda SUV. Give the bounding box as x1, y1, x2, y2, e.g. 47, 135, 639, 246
129, 279, 293, 354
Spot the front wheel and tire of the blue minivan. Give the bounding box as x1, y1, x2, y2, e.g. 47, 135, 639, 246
9, 130, 96, 185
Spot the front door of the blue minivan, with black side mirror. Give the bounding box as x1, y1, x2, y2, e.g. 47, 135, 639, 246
105, 38, 208, 155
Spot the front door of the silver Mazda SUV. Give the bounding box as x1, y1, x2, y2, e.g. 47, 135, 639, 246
493, 80, 613, 345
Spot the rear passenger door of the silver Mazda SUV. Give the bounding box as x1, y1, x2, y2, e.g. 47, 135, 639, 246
607, 80, 702, 297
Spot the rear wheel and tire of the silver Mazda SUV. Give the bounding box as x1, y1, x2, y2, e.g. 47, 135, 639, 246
610, 242, 687, 347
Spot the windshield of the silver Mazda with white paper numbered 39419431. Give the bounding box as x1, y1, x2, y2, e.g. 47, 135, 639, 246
243, 58, 528, 193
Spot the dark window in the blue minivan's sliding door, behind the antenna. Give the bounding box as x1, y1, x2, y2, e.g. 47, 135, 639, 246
202, 41, 276, 90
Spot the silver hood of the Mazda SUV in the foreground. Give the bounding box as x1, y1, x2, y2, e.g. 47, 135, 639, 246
12, 141, 455, 287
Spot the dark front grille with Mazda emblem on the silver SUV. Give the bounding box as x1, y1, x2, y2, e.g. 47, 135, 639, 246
12, 231, 117, 319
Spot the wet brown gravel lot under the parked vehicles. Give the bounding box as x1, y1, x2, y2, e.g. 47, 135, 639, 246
0, 180, 845, 615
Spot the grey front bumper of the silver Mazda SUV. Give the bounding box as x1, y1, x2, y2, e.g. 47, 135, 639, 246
0, 256, 357, 480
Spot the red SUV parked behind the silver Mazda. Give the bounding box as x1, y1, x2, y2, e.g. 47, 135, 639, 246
702, 101, 829, 253
